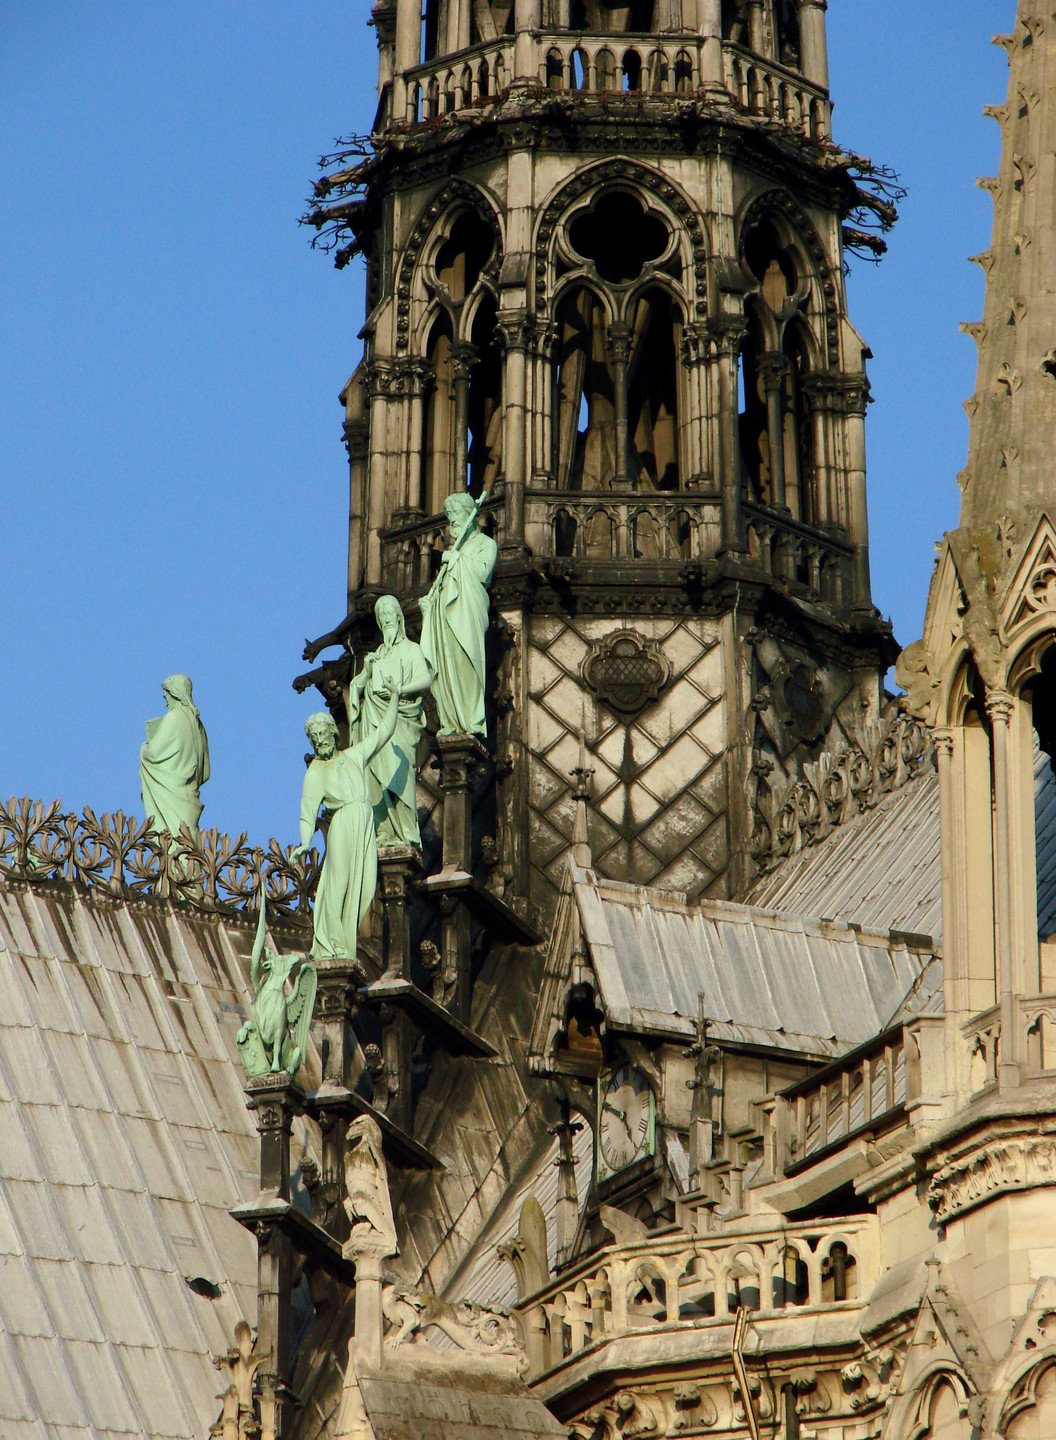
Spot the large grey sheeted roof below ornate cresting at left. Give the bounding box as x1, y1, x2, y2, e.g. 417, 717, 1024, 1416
0, 887, 283, 1440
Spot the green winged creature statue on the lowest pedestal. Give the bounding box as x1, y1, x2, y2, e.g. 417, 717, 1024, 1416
235, 887, 317, 1077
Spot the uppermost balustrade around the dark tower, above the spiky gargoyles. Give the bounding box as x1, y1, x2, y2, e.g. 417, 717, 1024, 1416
393, 30, 831, 140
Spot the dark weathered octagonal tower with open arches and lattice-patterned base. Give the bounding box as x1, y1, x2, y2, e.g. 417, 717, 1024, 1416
305, 0, 892, 920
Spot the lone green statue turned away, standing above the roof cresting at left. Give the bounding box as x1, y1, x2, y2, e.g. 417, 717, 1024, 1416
140, 675, 209, 835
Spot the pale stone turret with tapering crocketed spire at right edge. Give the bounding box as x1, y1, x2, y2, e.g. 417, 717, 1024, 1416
899, 0, 1056, 1370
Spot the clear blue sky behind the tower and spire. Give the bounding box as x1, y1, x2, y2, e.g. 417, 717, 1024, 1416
0, 0, 1016, 844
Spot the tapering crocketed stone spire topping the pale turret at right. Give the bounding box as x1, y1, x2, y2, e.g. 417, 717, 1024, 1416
961, 0, 1056, 553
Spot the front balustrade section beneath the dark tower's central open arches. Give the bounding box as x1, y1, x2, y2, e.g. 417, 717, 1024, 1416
524, 490, 722, 562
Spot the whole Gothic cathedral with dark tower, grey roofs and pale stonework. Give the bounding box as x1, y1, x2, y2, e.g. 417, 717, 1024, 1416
0, 0, 1056, 1440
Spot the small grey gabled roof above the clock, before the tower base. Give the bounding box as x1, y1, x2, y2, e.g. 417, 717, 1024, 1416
569, 865, 931, 1054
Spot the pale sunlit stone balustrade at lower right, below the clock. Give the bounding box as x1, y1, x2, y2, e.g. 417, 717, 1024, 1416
517, 1212, 879, 1377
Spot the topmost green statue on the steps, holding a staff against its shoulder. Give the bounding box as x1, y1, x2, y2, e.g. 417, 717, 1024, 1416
422, 492, 498, 734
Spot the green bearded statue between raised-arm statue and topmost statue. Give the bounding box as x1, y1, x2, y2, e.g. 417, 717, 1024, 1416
349, 595, 432, 850
